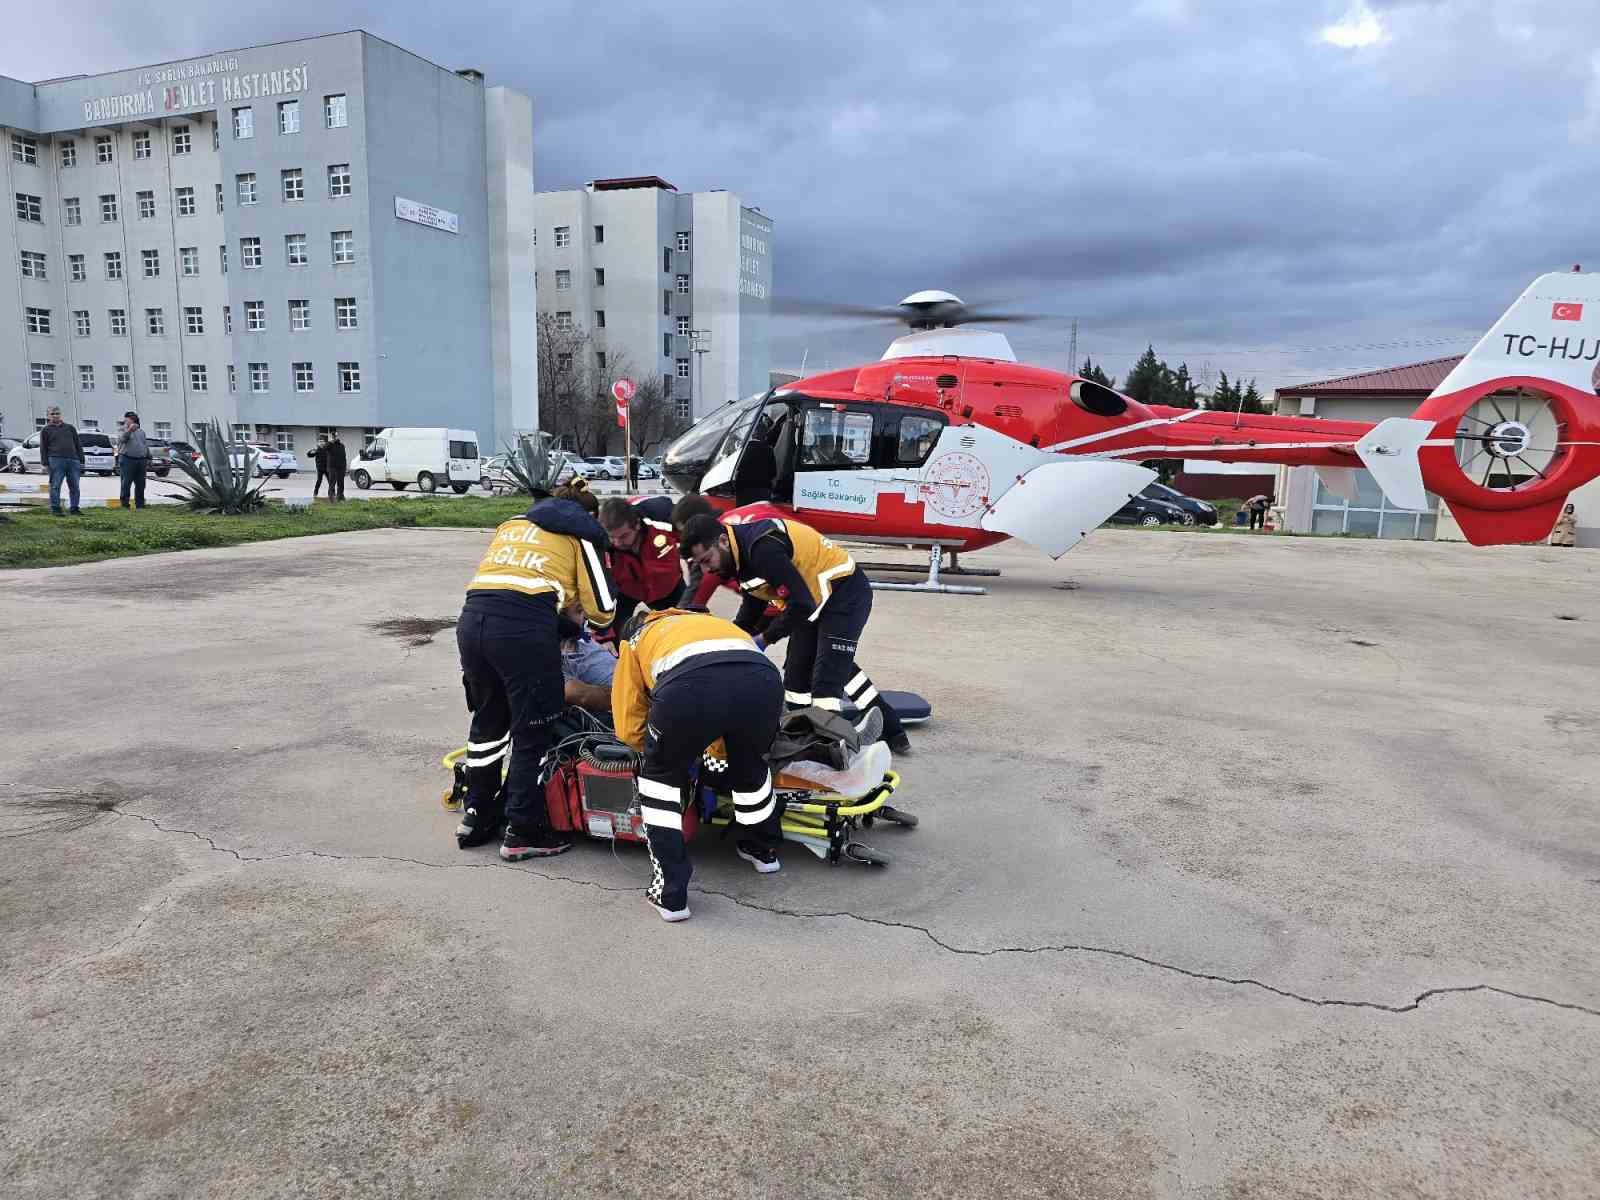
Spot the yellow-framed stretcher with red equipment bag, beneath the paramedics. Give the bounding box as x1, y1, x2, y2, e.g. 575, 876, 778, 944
442, 733, 917, 867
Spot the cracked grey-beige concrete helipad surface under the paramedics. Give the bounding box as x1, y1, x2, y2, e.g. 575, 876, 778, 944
0, 531, 1600, 1200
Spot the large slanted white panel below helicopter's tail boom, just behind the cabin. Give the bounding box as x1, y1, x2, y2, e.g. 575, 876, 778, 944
979, 459, 1155, 558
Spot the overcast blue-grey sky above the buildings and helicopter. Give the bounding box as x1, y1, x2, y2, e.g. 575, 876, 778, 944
0, 0, 1600, 387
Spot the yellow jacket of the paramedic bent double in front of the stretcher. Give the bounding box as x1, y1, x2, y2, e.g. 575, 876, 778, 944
611, 608, 778, 750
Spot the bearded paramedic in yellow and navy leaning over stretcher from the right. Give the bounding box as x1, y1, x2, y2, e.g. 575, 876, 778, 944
680, 515, 910, 754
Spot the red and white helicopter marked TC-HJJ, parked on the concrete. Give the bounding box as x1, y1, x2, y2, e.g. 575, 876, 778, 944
664, 272, 1600, 590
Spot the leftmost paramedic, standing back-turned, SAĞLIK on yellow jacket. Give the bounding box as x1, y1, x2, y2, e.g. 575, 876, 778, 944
456, 499, 616, 862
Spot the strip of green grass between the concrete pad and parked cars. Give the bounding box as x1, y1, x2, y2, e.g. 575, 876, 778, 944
0, 496, 530, 568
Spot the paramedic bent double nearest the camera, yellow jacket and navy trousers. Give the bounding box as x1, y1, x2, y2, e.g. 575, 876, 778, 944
611, 608, 784, 922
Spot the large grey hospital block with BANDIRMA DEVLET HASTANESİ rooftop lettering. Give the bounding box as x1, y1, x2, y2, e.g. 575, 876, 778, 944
0, 32, 538, 464
